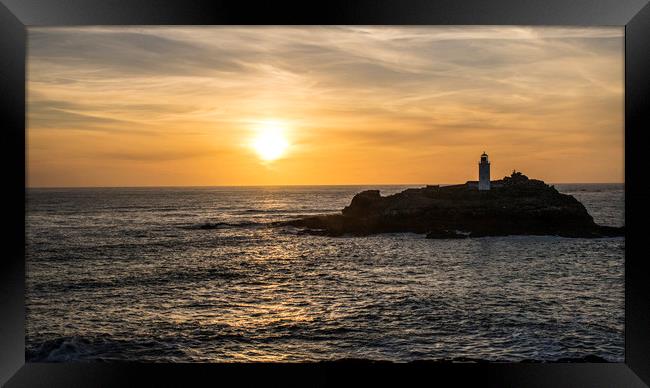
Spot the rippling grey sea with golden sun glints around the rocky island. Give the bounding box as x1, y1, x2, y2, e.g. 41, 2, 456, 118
26, 185, 625, 362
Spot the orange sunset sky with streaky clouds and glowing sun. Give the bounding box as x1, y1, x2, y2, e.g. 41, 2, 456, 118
27, 27, 624, 187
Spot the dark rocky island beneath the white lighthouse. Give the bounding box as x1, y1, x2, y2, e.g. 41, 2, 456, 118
282, 171, 624, 238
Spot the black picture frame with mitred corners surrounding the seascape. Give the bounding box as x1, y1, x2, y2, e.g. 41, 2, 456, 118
0, 0, 650, 387
